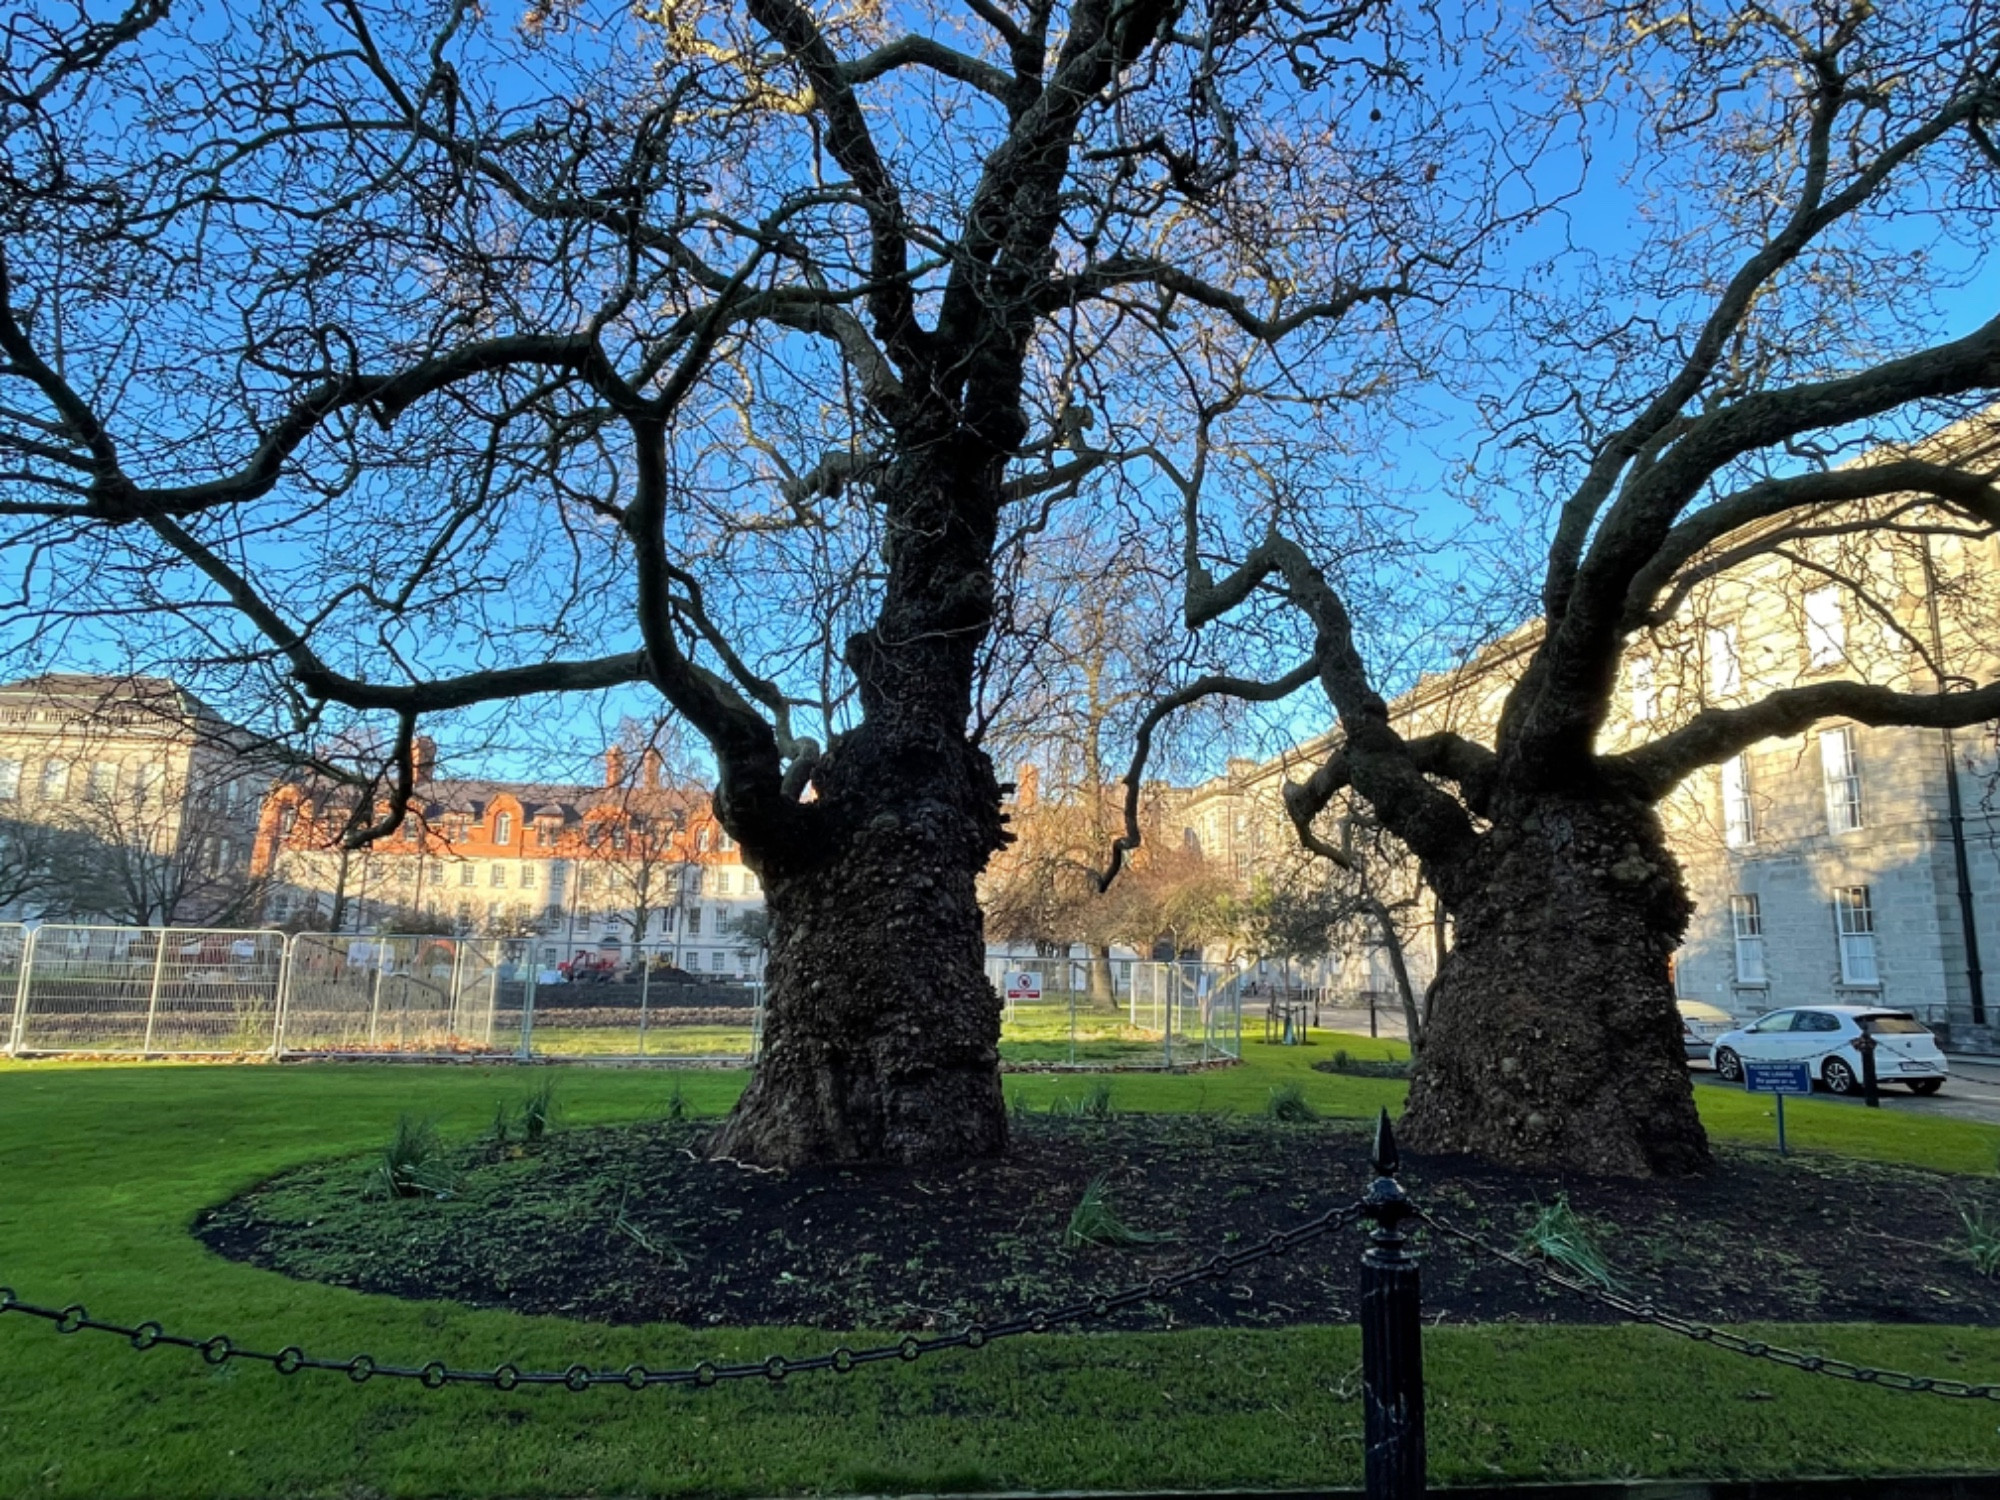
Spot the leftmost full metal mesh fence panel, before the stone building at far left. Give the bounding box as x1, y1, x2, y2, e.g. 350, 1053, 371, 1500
16, 922, 284, 1054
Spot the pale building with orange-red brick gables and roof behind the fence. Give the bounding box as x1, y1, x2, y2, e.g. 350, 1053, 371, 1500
254, 740, 764, 976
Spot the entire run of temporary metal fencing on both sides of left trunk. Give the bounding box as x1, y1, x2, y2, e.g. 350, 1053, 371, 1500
0, 922, 1242, 1068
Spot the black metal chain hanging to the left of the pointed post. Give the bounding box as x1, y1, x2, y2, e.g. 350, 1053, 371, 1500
0, 1204, 1362, 1390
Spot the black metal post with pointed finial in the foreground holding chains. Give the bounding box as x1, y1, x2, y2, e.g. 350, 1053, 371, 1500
1362, 1110, 1426, 1500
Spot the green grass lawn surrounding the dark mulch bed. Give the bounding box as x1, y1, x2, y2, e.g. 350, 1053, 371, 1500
0, 1038, 2000, 1496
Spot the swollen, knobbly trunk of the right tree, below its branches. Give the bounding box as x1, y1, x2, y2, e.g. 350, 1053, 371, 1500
1404, 796, 1710, 1176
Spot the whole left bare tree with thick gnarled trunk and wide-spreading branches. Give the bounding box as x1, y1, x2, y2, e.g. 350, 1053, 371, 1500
0, 0, 1512, 1164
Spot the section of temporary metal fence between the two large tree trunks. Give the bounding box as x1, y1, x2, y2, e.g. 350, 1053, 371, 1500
986, 956, 1244, 1068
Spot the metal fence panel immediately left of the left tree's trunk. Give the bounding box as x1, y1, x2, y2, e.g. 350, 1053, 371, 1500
528, 944, 764, 1062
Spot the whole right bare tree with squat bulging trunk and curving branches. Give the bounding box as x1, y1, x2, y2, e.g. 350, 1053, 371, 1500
1128, 0, 2000, 1174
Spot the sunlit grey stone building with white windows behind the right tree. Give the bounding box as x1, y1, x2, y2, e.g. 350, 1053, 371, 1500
1184, 414, 2000, 1052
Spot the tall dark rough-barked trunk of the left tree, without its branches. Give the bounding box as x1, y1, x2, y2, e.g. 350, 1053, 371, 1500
712, 442, 1008, 1168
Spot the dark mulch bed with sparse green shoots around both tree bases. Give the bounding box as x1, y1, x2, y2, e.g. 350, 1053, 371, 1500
194, 1116, 2000, 1330
